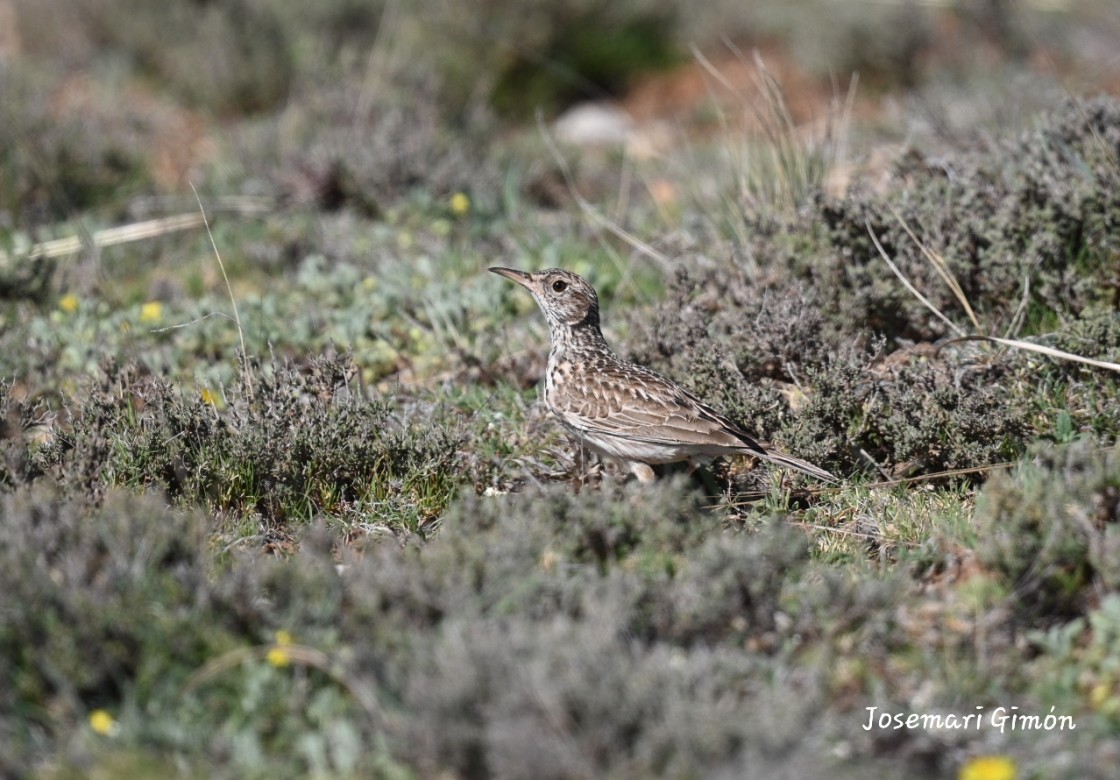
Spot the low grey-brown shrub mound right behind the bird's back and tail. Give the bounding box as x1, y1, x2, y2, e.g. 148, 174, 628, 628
635, 270, 1034, 476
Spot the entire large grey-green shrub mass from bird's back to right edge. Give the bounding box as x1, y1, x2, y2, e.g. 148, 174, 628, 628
628, 99, 1120, 476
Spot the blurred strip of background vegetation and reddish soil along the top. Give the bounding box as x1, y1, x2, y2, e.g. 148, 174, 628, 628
0, 0, 1116, 229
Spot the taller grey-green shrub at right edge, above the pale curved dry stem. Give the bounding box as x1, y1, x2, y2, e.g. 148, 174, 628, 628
810, 98, 1120, 340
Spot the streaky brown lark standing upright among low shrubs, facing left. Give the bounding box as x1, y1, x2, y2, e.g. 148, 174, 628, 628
489, 268, 839, 482
